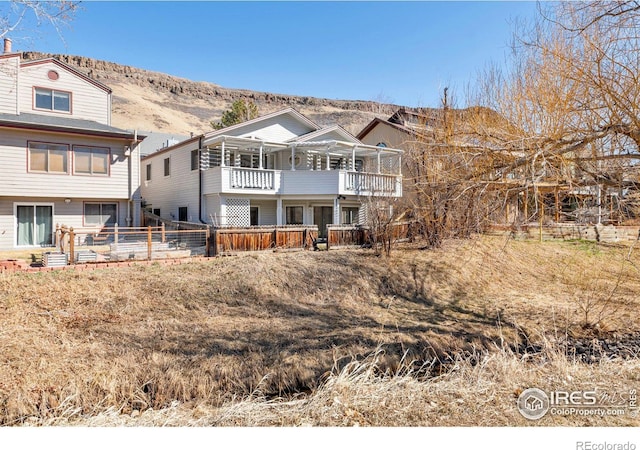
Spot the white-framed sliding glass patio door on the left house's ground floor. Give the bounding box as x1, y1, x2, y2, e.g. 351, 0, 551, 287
16, 205, 53, 247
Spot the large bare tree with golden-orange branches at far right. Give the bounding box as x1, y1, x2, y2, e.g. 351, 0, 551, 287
454, 2, 640, 229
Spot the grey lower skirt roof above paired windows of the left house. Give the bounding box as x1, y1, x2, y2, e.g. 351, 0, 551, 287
0, 113, 145, 141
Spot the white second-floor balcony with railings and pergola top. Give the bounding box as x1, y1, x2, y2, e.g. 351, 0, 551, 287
201, 136, 402, 197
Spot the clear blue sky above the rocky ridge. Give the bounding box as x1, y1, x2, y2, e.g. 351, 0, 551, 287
12, 1, 536, 106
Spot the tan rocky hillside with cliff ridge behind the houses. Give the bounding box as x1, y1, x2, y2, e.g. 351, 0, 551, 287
23, 52, 399, 135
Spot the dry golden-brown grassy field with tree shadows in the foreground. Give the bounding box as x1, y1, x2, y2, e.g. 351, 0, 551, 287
0, 237, 640, 426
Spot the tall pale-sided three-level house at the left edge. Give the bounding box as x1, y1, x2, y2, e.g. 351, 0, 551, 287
0, 40, 143, 249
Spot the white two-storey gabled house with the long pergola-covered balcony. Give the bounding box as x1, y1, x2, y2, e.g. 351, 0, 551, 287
141, 108, 402, 236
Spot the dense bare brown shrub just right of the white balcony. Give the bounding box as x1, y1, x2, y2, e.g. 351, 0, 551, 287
404, 88, 501, 246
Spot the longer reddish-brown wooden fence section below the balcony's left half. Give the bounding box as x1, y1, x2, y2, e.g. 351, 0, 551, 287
211, 225, 318, 256
